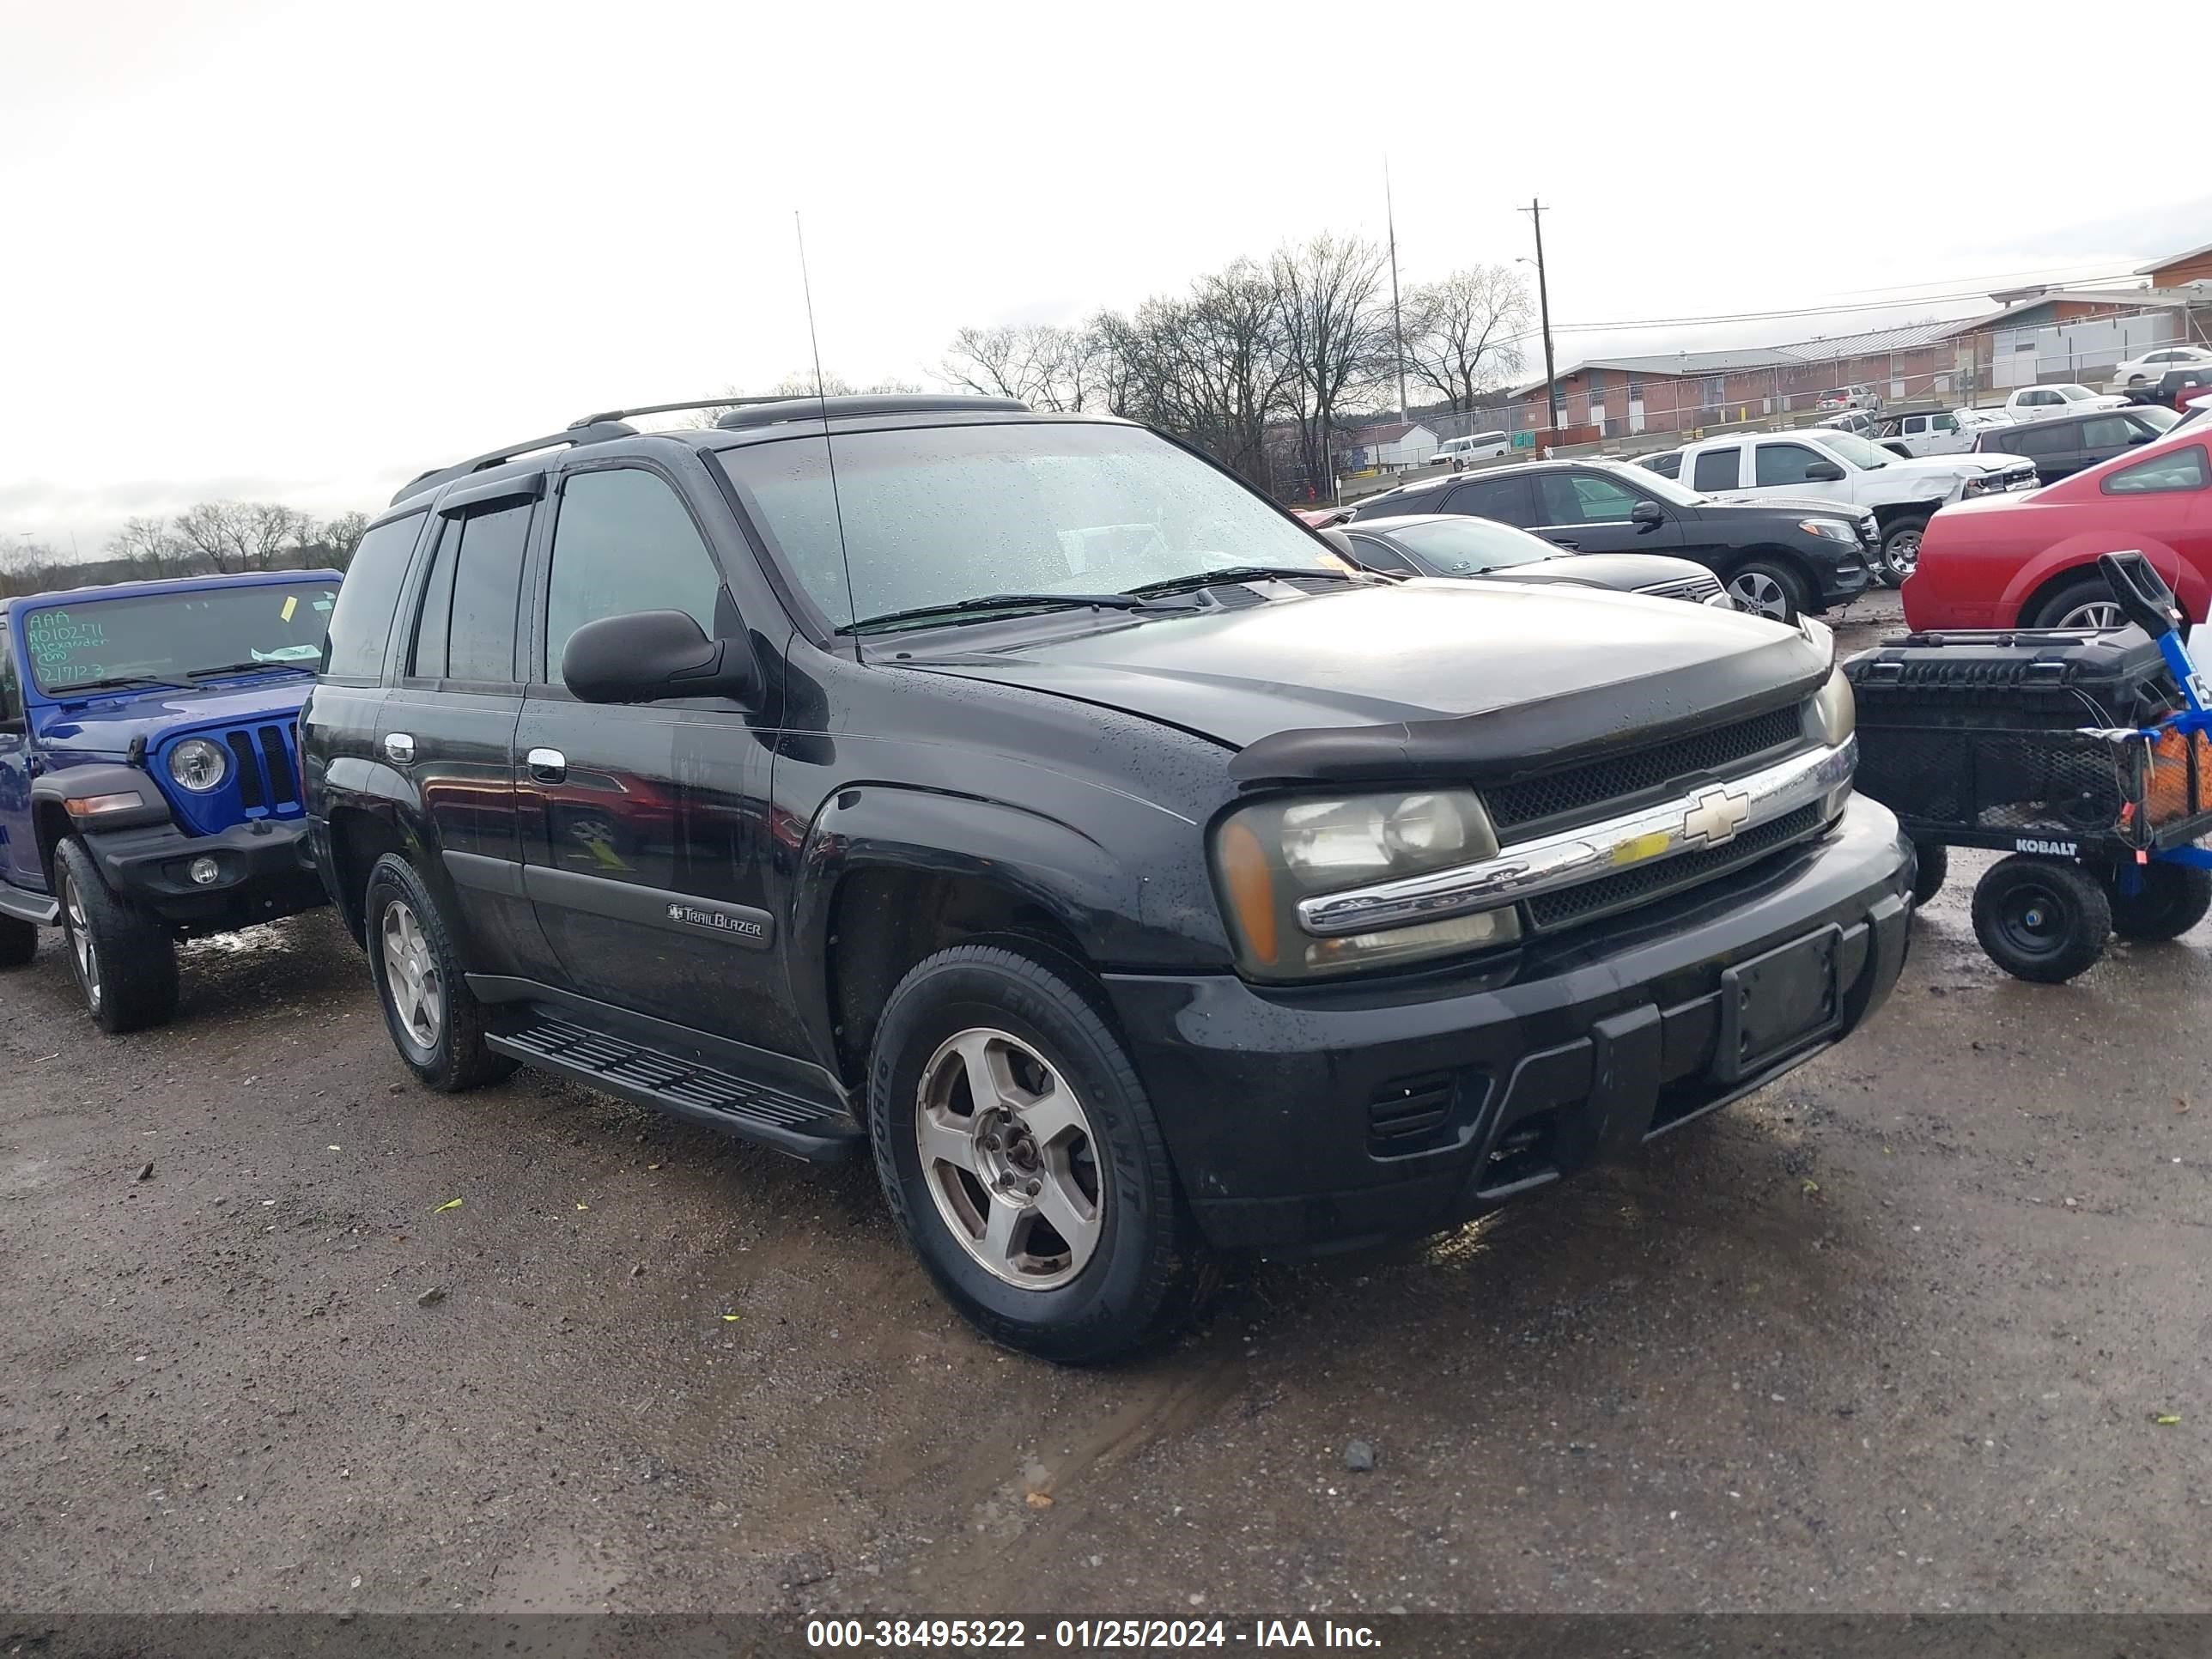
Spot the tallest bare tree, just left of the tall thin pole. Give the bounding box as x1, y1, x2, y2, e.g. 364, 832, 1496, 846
1267, 232, 1389, 500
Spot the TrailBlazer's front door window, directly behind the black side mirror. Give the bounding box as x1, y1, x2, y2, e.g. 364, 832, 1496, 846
546, 467, 728, 677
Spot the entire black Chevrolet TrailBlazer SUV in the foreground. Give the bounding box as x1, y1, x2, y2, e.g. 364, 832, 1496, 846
303, 396, 1913, 1360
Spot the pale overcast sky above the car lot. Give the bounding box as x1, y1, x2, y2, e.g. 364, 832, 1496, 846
0, 0, 2212, 556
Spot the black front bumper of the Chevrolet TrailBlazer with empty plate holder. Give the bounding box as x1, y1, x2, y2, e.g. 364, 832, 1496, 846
1106, 799, 1913, 1249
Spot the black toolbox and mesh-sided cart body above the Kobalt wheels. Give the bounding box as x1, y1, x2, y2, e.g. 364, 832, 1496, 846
1843, 629, 2212, 856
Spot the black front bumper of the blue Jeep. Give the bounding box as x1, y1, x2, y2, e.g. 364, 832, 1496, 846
84, 818, 327, 933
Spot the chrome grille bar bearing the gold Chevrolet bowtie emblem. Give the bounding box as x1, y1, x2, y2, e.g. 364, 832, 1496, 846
1298, 737, 1858, 938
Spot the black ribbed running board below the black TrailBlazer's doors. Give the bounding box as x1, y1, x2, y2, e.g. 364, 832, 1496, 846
484, 1009, 865, 1164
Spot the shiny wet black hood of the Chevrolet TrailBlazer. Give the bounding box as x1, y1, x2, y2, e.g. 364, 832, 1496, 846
905, 580, 1832, 783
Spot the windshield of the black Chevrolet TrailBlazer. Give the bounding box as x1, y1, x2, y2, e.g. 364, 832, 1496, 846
717, 420, 1345, 629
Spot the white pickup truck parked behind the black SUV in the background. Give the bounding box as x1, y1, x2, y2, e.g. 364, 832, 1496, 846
1674, 427, 2035, 586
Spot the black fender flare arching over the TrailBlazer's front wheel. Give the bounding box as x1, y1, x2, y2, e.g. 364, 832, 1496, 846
785, 783, 1141, 1055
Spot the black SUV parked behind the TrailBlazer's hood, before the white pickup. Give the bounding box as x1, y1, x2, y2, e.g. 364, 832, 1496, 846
1352, 460, 1878, 622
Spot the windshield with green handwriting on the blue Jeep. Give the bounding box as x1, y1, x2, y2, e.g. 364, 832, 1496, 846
22, 580, 338, 696
